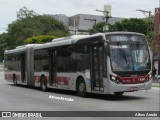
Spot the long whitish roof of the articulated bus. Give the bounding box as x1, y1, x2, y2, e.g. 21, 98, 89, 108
5, 31, 144, 54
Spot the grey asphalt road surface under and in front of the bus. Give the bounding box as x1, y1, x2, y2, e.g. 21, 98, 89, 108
0, 72, 160, 120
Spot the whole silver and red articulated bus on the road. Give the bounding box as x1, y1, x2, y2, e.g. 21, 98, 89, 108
4, 32, 152, 96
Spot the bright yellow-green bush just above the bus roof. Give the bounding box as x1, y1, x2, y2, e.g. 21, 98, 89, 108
24, 35, 55, 44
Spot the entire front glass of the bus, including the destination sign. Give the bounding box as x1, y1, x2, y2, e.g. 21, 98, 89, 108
107, 35, 151, 71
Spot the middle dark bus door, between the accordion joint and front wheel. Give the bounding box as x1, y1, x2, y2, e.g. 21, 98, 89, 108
49, 50, 57, 86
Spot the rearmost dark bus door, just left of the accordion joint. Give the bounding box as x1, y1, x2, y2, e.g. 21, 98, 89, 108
21, 54, 26, 83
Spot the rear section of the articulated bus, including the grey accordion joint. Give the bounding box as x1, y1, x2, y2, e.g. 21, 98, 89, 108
4, 45, 35, 86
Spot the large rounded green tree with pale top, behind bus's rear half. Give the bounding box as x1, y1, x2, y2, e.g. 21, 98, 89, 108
6, 7, 69, 49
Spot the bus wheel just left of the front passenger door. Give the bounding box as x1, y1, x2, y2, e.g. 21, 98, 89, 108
77, 78, 86, 97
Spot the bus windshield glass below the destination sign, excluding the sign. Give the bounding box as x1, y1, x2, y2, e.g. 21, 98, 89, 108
110, 44, 150, 71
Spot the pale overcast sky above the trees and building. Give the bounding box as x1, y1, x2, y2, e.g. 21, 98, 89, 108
0, 0, 160, 33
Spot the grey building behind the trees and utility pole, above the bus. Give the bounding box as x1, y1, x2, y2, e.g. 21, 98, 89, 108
51, 14, 124, 34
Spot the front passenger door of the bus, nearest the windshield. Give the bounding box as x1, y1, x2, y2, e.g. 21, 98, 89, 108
91, 43, 103, 91
